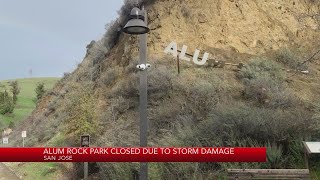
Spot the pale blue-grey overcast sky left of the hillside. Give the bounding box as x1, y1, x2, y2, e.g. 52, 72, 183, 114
0, 0, 123, 80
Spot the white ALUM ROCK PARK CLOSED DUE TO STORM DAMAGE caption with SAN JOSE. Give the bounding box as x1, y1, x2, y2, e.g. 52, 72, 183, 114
43, 148, 235, 161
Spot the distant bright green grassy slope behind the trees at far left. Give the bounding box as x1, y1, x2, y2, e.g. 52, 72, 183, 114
0, 78, 59, 127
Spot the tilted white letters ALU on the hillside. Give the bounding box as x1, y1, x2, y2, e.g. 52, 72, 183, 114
164, 41, 209, 65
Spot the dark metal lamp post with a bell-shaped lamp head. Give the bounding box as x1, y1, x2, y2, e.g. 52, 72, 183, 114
123, 8, 150, 180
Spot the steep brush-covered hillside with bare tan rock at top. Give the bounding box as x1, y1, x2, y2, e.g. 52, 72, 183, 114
7, 0, 320, 179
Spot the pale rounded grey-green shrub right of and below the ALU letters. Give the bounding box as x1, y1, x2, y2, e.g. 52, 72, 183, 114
238, 58, 298, 108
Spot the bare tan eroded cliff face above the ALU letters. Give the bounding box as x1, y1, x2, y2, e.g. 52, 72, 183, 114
148, 0, 320, 54
